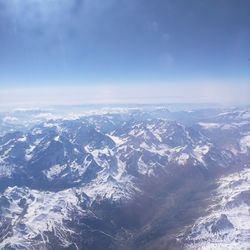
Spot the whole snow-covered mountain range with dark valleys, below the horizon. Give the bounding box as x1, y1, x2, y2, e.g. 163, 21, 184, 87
0, 108, 250, 249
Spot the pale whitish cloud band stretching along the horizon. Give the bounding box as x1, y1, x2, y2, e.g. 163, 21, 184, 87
0, 81, 250, 108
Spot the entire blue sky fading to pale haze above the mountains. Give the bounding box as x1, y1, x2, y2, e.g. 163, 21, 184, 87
0, 0, 250, 105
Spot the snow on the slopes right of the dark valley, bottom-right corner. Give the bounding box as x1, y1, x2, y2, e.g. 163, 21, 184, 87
185, 168, 250, 250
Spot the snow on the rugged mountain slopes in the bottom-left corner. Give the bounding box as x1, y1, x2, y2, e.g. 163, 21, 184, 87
0, 187, 85, 249
